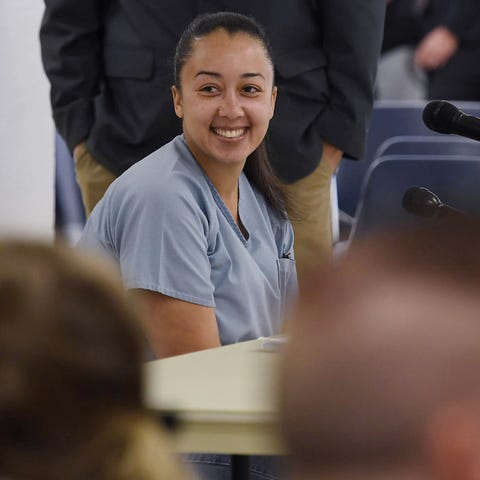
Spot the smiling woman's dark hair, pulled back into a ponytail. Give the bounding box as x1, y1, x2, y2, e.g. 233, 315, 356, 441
174, 12, 291, 216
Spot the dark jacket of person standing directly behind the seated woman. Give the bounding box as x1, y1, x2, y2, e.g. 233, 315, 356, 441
40, 0, 385, 182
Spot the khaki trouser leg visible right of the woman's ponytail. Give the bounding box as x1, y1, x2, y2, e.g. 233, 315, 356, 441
287, 160, 333, 289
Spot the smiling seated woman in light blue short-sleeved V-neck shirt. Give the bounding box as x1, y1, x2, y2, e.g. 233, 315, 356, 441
80, 12, 297, 357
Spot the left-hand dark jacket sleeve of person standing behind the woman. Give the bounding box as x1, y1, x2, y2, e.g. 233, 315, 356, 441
40, 0, 103, 151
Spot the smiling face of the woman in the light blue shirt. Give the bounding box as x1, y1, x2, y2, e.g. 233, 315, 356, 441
172, 30, 277, 174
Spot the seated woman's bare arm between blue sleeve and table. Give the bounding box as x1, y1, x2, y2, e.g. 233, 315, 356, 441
132, 289, 221, 358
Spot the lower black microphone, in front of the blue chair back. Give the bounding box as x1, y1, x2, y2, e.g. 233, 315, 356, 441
402, 186, 467, 218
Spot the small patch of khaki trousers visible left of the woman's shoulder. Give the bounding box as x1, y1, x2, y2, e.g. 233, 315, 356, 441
75, 143, 117, 217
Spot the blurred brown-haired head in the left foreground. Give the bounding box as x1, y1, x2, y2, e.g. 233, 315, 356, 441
0, 240, 186, 480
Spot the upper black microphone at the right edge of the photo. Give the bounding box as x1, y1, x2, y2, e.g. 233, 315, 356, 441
423, 100, 480, 141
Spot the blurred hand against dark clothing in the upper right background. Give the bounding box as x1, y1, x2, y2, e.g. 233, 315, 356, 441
414, 26, 459, 70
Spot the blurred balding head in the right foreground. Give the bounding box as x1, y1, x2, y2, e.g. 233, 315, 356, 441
282, 220, 480, 480
